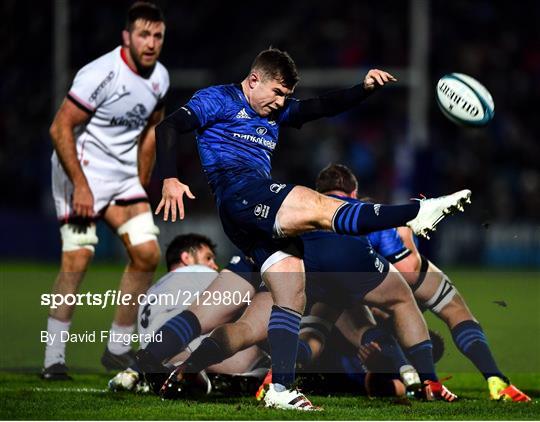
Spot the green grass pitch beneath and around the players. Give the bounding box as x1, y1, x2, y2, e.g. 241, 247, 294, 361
0, 263, 540, 420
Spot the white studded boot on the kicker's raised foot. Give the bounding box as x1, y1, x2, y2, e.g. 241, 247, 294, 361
407, 189, 472, 239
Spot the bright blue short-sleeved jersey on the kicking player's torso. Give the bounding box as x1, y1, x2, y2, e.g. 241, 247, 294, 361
186, 84, 298, 195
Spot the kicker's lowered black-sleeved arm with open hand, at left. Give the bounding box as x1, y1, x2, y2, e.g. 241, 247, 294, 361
155, 107, 200, 222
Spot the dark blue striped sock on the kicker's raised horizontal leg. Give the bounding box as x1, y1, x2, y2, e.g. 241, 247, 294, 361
332, 202, 420, 235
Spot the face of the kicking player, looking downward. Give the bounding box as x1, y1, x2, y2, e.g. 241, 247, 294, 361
249, 75, 293, 117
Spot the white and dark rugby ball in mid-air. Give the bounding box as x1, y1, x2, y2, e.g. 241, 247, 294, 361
437, 73, 495, 127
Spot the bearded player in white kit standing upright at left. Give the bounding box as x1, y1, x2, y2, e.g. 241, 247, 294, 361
42, 2, 169, 379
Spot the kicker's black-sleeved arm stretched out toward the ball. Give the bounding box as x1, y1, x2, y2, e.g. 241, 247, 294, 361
283, 69, 396, 127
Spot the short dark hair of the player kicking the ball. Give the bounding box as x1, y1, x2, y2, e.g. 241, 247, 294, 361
251, 47, 300, 89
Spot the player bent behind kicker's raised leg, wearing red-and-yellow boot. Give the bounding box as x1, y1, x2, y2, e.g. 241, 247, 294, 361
310, 164, 531, 402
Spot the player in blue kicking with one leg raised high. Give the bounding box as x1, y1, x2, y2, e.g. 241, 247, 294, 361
150, 49, 471, 410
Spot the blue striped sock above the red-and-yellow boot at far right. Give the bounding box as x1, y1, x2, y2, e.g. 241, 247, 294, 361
452, 320, 508, 382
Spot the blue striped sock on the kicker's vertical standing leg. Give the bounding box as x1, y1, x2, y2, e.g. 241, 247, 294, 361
268, 305, 301, 388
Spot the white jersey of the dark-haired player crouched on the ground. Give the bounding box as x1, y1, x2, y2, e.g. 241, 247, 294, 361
137, 265, 218, 348
